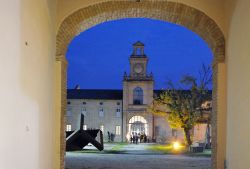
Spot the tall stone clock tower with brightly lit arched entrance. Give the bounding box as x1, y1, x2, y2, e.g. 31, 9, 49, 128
123, 41, 154, 140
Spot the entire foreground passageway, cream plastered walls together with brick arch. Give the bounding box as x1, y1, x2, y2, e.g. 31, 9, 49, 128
0, 0, 250, 169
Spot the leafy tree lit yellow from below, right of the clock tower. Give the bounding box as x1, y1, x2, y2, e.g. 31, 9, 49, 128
151, 64, 212, 146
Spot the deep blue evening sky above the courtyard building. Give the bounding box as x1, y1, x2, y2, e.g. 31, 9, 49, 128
66, 19, 213, 89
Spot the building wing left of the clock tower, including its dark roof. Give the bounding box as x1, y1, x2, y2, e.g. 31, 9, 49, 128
66, 89, 123, 142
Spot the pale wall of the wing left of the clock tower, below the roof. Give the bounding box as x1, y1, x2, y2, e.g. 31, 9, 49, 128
65, 99, 122, 142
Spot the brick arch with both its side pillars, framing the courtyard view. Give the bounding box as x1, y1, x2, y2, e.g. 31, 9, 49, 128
56, 0, 225, 169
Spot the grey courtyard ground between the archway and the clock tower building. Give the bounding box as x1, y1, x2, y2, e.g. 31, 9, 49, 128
65, 144, 211, 169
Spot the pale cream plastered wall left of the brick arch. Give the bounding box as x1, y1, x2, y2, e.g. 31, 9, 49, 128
0, 0, 55, 169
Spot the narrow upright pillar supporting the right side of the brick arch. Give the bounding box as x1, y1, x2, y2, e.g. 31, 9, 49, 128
211, 62, 227, 169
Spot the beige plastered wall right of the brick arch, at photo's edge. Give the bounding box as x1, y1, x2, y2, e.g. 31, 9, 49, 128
227, 0, 250, 169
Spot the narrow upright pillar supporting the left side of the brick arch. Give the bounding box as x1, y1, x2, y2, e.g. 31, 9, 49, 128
54, 55, 67, 169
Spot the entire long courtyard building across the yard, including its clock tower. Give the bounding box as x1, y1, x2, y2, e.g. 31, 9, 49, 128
66, 41, 207, 143
